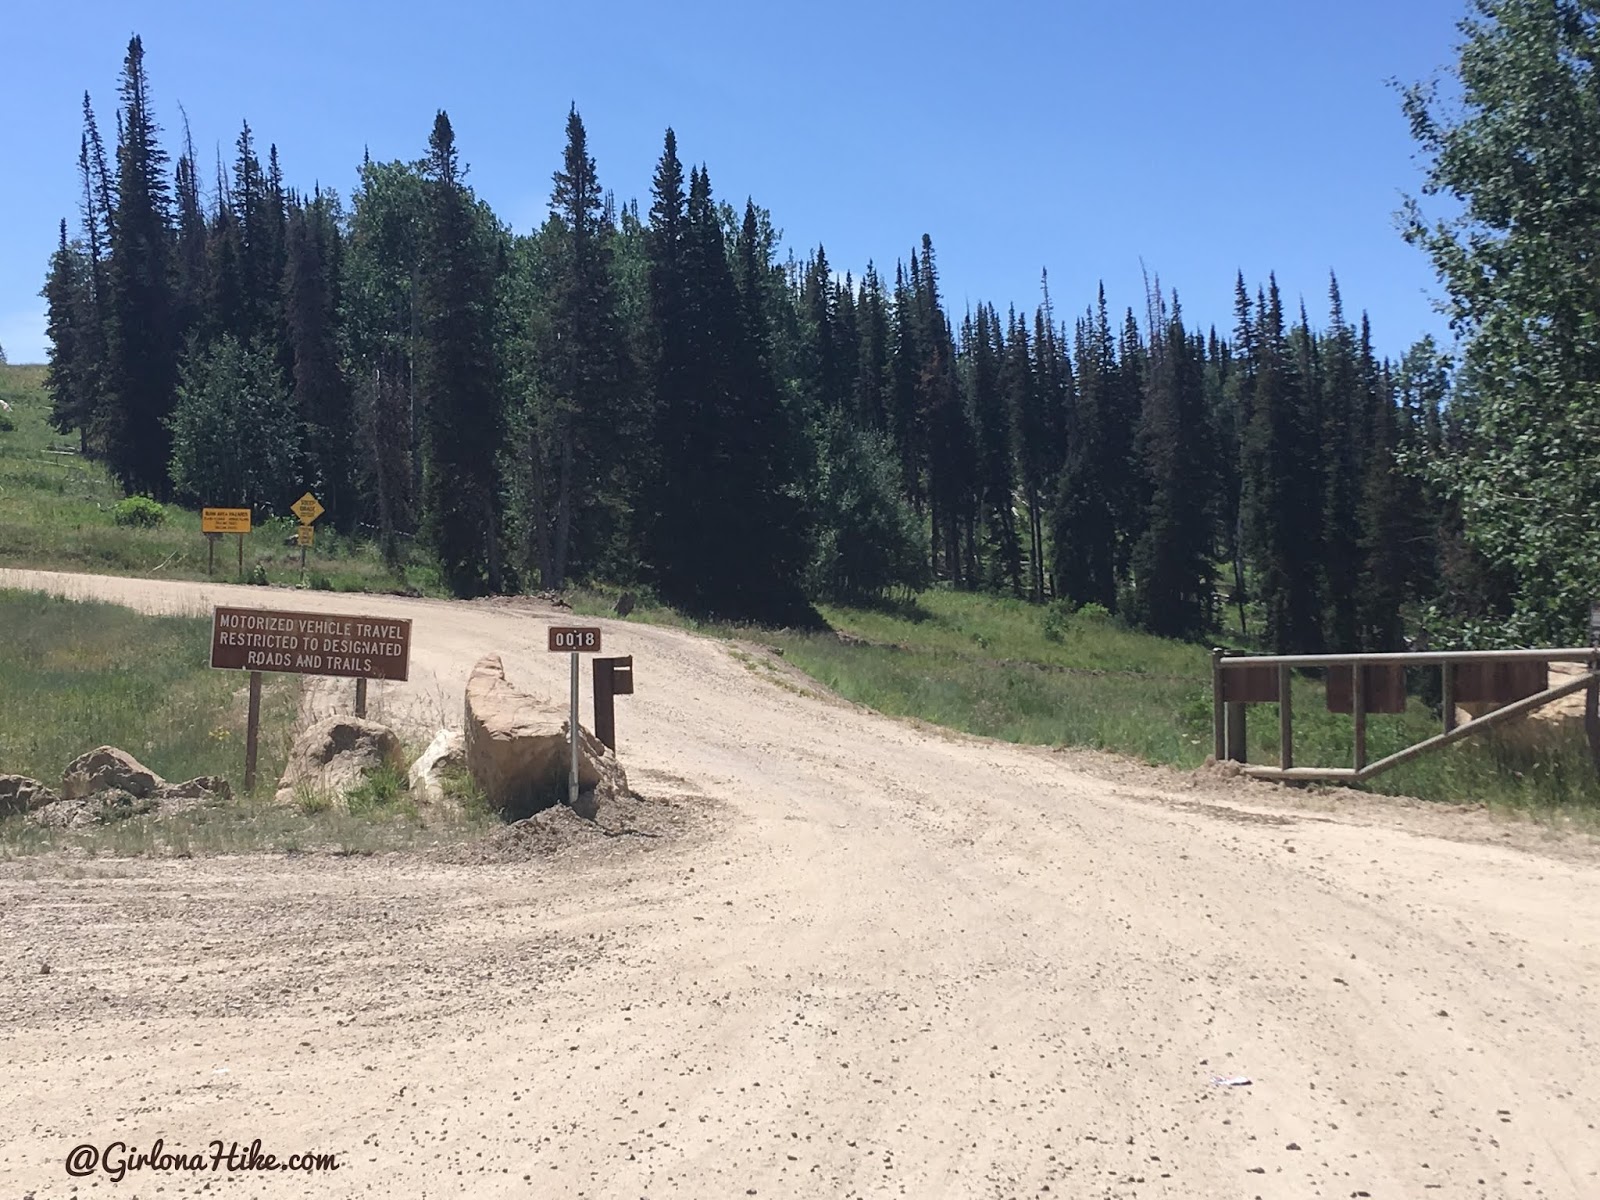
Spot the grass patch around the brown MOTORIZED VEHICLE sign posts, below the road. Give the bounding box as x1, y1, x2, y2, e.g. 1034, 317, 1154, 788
0, 590, 486, 858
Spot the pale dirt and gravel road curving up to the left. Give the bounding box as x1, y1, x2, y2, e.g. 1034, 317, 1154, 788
0, 571, 1600, 1200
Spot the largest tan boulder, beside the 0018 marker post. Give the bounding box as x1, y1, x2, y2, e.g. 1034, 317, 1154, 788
466, 654, 627, 821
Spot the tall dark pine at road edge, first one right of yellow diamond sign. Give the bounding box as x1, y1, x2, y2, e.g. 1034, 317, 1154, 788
418, 110, 504, 595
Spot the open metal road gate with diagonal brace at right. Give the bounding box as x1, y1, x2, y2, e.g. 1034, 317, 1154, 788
1211, 646, 1600, 782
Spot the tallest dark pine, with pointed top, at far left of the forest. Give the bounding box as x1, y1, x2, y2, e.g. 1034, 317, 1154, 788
102, 37, 181, 499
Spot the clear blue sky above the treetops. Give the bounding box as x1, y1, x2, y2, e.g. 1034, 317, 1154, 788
0, 0, 1466, 362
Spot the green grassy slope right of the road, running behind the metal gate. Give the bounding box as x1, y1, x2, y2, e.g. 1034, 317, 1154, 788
573, 589, 1600, 819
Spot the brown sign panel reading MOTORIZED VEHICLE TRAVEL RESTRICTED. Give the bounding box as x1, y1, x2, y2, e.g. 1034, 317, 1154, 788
211, 608, 411, 680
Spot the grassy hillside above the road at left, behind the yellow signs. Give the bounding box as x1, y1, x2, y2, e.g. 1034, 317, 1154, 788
0, 366, 438, 594
